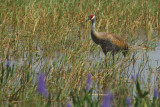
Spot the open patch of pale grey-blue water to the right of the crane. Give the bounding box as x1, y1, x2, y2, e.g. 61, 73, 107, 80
129, 42, 160, 83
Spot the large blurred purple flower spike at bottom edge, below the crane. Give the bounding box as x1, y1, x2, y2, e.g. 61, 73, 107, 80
101, 92, 113, 107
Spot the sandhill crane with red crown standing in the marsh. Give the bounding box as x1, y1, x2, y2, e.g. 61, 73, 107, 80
87, 15, 128, 63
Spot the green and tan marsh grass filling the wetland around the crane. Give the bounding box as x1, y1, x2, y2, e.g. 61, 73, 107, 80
0, 0, 160, 106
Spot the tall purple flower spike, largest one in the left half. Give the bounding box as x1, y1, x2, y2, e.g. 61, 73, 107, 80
37, 73, 48, 97
